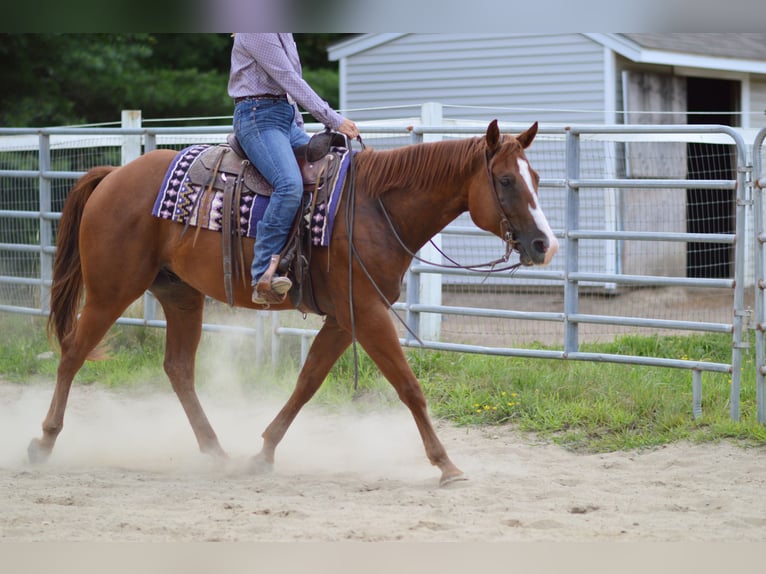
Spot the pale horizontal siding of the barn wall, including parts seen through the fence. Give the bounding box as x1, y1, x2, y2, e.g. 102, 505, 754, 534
343, 34, 608, 283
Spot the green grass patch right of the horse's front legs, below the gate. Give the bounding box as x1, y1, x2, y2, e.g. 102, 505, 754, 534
412, 335, 766, 452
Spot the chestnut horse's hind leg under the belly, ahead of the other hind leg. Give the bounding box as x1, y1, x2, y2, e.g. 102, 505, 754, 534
151, 280, 226, 457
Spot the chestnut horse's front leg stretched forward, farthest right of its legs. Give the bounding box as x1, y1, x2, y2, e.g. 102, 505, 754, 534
357, 308, 465, 486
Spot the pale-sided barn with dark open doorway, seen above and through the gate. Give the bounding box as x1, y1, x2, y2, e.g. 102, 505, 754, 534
329, 33, 766, 284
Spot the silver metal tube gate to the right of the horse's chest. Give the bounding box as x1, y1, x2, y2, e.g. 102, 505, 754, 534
404, 125, 750, 420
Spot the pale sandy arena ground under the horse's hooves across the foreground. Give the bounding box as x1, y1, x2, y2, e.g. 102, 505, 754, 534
0, 382, 766, 542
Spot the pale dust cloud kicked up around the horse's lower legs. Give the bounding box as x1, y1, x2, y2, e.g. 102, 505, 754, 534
0, 338, 434, 478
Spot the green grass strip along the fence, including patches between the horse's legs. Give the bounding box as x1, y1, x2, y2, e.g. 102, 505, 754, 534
0, 315, 766, 452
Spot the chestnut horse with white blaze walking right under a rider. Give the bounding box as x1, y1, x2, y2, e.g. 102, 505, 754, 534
28, 120, 558, 485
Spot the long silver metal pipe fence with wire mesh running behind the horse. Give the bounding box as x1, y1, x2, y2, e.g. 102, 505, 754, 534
0, 116, 766, 419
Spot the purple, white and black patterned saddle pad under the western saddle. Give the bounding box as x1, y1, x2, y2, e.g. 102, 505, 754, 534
152, 144, 353, 247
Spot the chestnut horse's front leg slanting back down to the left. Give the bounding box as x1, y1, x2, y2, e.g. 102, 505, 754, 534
252, 317, 351, 471
